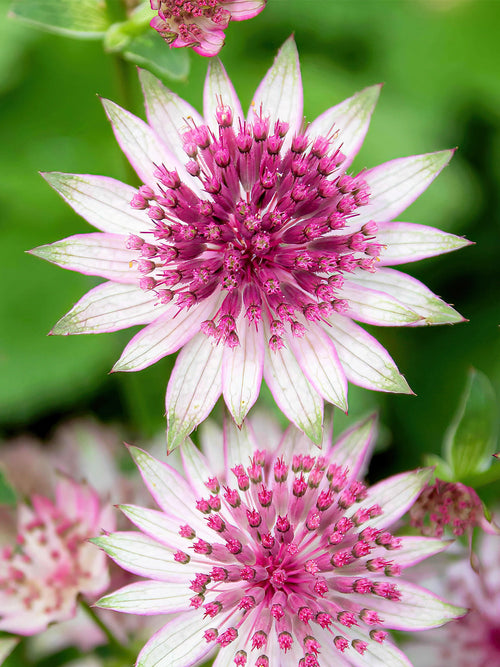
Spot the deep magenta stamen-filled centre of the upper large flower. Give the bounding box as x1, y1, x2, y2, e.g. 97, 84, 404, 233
127, 104, 381, 349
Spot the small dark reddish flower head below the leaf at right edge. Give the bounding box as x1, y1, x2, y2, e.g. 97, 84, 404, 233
410, 479, 499, 538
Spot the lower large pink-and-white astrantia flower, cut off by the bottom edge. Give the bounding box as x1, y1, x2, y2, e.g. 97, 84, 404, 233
94, 419, 464, 667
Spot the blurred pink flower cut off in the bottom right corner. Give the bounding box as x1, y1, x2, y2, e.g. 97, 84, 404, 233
407, 533, 500, 667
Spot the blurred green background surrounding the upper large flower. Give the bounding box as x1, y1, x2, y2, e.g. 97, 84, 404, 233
0, 0, 500, 664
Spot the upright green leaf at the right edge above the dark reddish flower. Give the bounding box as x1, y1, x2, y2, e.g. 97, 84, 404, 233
443, 369, 497, 481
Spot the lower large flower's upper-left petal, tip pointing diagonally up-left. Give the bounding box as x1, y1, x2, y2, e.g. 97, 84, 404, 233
129, 447, 199, 526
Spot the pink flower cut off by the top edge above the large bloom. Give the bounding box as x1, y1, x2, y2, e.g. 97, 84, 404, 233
150, 0, 266, 56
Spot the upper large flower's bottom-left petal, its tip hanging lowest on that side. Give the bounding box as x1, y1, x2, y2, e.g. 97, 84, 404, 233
166, 333, 224, 451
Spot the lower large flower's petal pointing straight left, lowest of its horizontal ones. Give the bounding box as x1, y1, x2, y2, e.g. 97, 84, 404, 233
95, 581, 190, 616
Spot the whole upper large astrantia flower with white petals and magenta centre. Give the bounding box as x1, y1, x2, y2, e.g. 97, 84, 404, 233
32, 40, 468, 448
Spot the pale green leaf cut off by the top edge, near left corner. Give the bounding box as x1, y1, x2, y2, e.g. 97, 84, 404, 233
11, 0, 111, 39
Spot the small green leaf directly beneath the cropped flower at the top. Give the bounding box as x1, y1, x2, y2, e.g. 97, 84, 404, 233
122, 27, 190, 80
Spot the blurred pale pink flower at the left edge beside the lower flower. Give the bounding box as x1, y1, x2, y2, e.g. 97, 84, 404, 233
0, 476, 115, 635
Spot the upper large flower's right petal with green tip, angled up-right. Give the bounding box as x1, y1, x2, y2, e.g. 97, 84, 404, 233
356, 150, 454, 225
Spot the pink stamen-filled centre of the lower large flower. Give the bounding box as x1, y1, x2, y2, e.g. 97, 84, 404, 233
174, 451, 401, 667
